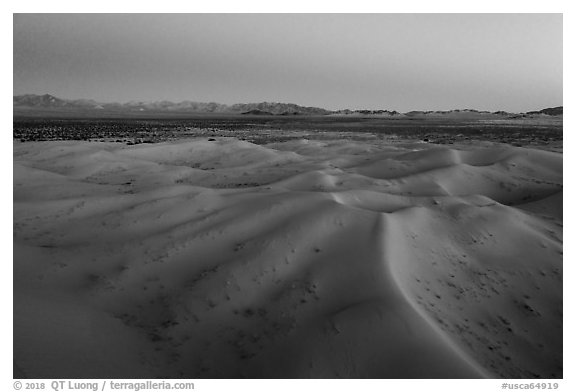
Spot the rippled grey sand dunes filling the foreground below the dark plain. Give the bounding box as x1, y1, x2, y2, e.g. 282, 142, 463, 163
14, 138, 562, 378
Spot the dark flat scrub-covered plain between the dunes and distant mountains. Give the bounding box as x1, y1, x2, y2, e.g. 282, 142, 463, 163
13, 116, 562, 146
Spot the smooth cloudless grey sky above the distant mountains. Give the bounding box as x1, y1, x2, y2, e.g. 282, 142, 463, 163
14, 14, 563, 112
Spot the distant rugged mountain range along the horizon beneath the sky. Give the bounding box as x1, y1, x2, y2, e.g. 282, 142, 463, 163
13, 94, 563, 117
